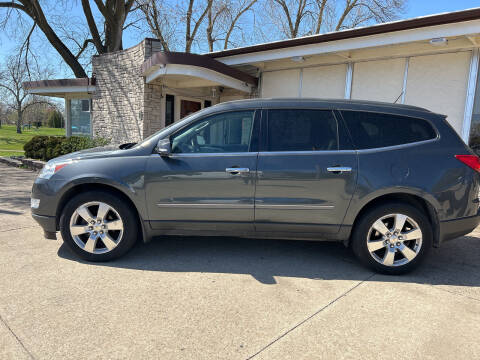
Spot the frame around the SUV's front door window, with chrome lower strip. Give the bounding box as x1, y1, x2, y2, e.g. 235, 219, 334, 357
168, 108, 262, 157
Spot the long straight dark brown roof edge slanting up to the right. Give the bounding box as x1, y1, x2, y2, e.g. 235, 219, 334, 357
206, 8, 480, 58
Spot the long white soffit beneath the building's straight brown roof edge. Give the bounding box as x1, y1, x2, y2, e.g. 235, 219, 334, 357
216, 20, 480, 65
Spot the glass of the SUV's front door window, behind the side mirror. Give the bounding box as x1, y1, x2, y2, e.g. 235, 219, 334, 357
171, 111, 255, 154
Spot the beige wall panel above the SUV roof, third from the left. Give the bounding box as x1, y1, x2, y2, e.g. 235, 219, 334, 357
352, 58, 405, 103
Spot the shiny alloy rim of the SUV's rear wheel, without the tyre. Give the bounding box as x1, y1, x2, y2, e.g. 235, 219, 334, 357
367, 214, 422, 266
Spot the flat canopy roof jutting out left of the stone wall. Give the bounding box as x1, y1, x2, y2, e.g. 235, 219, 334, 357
23, 78, 95, 98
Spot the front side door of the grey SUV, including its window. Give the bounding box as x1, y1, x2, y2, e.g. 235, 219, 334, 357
145, 110, 260, 233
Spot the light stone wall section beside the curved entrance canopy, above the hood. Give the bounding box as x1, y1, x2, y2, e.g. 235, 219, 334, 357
91, 39, 164, 143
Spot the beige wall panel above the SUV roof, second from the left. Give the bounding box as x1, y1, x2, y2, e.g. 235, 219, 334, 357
302, 64, 347, 99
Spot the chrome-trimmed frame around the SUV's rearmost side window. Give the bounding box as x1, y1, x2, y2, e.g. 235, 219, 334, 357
337, 108, 441, 152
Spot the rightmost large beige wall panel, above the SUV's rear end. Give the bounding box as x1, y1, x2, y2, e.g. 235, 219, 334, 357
405, 51, 471, 134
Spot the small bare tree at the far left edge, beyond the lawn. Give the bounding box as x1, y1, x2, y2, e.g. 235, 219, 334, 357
0, 57, 48, 134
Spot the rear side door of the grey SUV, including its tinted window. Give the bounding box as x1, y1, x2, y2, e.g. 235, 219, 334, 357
255, 109, 357, 236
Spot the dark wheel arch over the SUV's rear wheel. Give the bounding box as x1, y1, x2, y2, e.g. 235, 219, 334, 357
347, 192, 440, 247
